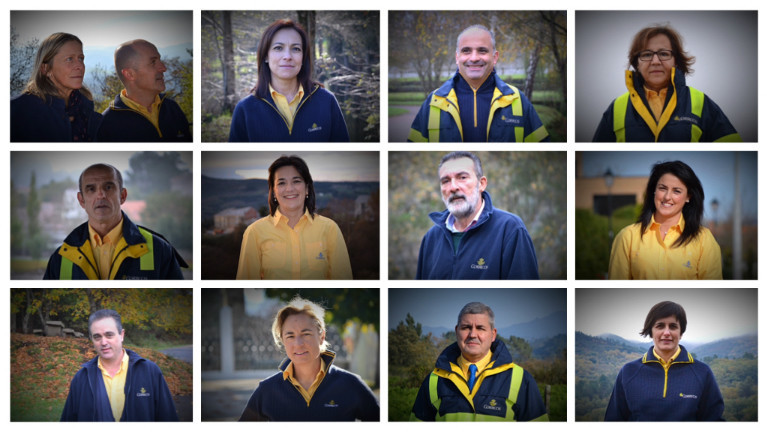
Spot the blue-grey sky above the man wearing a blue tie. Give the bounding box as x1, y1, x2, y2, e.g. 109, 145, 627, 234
389, 288, 567, 331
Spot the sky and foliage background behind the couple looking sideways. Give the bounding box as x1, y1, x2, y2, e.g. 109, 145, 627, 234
11, 10, 194, 128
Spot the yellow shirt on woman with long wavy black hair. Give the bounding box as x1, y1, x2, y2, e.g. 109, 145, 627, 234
607, 216, 722, 279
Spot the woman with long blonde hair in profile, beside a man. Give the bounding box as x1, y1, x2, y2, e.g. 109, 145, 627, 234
11, 33, 101, 142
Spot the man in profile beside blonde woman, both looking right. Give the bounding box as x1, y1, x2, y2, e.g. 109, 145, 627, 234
97, 39, 192, 142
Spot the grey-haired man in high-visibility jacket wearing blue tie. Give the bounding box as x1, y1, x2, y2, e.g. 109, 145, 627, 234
410, 302, 549, 421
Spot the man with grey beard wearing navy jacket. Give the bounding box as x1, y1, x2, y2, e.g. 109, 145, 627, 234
415, 151, 538, 279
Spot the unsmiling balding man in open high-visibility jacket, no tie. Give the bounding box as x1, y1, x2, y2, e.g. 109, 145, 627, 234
43, 164, 187, 279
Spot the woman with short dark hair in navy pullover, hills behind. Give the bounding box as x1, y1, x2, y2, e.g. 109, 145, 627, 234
605, 301, 724, 421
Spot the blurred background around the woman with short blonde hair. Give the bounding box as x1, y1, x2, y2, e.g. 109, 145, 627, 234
201, 288, 381, 421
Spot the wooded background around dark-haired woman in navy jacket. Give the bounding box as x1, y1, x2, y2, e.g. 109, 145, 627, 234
200, 11, 381, 142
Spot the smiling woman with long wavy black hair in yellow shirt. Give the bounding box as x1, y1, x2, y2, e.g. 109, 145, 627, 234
607, 161, 722, 279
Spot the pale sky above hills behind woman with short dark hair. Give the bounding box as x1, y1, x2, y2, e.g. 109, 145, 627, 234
575, 288, 757, 343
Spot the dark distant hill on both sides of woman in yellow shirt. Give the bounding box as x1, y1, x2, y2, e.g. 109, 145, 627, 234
200, 175, 380, 219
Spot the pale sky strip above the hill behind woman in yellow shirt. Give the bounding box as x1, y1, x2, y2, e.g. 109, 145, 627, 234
202, 151, 381, 182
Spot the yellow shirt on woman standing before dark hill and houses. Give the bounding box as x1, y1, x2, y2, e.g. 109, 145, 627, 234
237, 210, 352, 279
